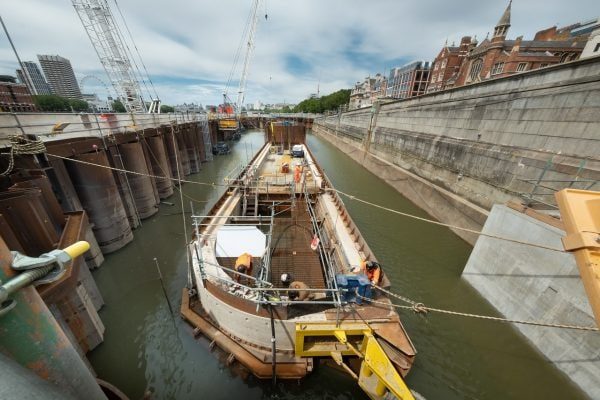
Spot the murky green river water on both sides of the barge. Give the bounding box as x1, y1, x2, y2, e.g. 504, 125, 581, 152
88, 131, 586, 400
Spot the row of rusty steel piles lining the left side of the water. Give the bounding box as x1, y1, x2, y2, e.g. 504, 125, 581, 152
0, 122, 210, 399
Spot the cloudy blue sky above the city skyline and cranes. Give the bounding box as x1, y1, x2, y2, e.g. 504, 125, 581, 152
0, 0, 600, 105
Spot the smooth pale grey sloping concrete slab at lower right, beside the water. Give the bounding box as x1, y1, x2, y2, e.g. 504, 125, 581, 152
463, 205, 600, 399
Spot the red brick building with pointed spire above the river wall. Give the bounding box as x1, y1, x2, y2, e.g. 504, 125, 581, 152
428, 0, 587, 92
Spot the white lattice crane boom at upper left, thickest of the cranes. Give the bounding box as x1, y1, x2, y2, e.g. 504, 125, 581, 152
71, 0, 160, 113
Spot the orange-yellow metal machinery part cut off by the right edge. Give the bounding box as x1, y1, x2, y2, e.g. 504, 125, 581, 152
556, 189, 600, 327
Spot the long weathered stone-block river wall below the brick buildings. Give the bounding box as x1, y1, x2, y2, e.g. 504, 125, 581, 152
313, 58, 600, 216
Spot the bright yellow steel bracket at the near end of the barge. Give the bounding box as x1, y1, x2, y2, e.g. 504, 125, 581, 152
295, 322, 415, 400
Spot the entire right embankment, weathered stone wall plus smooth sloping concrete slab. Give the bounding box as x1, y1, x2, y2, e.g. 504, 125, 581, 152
313, 57, 600, 398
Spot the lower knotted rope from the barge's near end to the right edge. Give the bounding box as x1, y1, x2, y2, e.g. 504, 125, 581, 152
368, 285, 600, 332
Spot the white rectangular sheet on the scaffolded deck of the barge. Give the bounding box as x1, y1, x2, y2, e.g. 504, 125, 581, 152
215, 225, 267, 257
